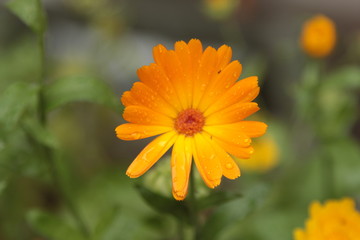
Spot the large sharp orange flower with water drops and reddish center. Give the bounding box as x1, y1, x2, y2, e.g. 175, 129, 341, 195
116, 39, 267, 200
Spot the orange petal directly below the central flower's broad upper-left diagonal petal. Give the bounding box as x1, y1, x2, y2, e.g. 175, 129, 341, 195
130, 82, 177, 118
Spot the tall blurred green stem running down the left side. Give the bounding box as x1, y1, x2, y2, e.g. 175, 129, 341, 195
38, 24, 90, 239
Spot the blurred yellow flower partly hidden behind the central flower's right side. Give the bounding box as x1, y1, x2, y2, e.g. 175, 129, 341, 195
237, 134, 279, 172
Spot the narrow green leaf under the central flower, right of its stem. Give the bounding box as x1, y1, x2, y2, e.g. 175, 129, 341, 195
197, 191, 242, 210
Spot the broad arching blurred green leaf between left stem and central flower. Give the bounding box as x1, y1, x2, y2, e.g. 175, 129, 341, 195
44, 76, 121, 112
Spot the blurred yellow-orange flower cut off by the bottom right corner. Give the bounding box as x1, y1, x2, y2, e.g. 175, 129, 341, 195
294, 198, 360, 240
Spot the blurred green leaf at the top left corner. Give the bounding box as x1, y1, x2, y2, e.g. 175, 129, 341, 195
6, 0, 46, 34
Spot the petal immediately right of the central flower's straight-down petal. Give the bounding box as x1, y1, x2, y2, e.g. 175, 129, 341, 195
193, 134, 222, 188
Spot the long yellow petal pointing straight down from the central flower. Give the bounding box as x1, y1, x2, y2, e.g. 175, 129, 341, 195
171, 135, 194, 200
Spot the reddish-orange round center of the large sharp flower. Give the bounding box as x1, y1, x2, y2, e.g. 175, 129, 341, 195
175, 108, 205, 136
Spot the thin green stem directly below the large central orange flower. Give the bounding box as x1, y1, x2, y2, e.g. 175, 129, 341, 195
189, 166, 200, 240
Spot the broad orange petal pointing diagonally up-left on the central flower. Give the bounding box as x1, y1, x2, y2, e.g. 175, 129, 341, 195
137, 64, 181, 111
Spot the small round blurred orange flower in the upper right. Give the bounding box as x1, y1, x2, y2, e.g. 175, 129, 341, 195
301, 14, 336, 58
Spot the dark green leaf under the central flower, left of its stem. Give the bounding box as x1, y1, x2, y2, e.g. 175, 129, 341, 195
136, 184, 188, 220
